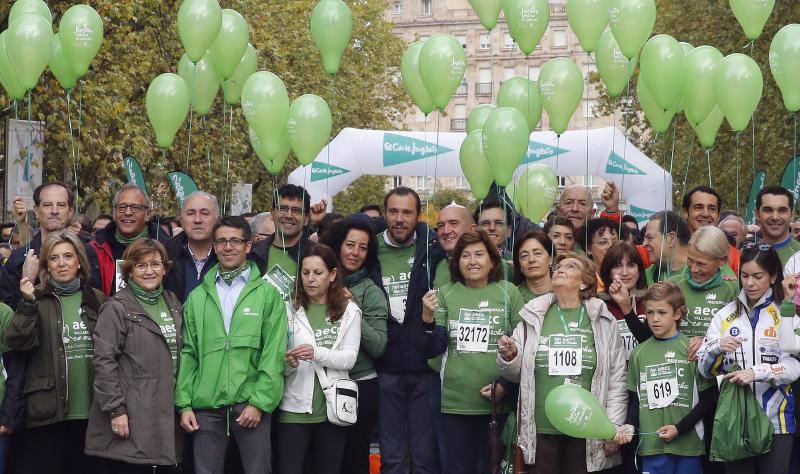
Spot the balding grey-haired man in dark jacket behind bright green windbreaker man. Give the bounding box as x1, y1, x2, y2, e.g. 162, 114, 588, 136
164, 191, 220, 303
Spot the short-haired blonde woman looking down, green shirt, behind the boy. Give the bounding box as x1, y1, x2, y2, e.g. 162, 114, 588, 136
670, 226, 739, 359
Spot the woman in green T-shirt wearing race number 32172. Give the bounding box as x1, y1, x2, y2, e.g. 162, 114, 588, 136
422, 230, 523, 474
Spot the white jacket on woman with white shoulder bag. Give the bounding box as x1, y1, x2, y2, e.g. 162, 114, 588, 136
280, 301, 361, 413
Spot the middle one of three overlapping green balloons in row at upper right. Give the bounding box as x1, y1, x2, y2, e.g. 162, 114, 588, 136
682, 46, 723, 125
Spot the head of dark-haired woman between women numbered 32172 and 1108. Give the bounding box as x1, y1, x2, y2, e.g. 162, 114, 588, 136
514, 230, 556, 303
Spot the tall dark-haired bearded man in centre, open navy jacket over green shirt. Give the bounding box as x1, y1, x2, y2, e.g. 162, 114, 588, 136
378, 187, 445, 474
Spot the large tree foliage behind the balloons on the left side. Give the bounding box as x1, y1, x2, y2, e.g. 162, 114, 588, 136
0, 0, 410, 213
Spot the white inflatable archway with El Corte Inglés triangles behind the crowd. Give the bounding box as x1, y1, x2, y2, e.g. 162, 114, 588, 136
289, 127, 672, 222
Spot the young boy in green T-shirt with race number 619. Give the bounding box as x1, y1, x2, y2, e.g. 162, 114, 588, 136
614, 281, 715, 474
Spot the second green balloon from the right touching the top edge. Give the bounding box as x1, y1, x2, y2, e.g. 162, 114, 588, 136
608, 0, 656, 59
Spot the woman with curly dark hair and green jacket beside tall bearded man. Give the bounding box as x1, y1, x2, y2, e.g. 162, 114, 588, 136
322, 215, 389, 474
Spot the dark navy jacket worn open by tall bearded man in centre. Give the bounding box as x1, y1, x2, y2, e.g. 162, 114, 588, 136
378, 223, 447, 373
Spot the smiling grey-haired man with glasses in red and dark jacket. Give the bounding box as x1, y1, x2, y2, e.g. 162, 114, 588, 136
89, 183, 169, 296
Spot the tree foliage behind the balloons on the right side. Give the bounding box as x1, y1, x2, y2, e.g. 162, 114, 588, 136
593, 0, 800, 212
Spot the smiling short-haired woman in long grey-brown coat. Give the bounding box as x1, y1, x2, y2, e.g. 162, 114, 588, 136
86, 239, 183, 474
